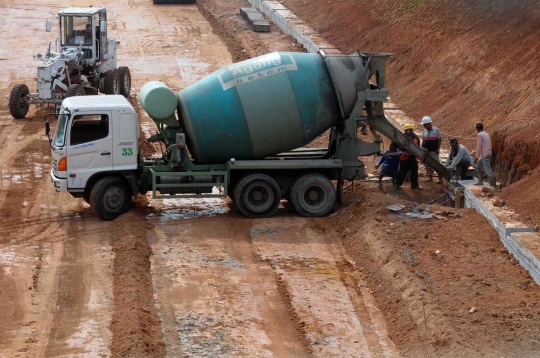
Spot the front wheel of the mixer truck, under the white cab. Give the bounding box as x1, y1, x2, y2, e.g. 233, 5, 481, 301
90, 177, 131, 221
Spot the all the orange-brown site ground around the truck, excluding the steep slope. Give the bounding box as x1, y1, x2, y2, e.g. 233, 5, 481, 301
0, 0, 540, 357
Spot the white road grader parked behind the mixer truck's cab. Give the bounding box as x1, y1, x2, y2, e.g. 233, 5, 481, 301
9, 7, 131, 119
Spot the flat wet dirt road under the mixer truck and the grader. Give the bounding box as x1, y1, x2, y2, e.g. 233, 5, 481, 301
0, 1, 397, 357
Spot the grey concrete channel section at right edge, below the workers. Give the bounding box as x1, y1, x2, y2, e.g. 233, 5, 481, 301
459, 186, 540, 285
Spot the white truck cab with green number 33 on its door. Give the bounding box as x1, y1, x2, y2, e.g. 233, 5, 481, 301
51, 95, 139, 205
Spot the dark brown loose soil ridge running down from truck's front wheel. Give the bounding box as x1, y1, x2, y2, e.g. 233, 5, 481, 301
109, 211, 166, 358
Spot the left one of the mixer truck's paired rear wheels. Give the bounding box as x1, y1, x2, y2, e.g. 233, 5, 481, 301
234, 174, 281, 219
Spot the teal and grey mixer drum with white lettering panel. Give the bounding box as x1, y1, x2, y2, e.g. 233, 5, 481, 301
178, 52, 341, 163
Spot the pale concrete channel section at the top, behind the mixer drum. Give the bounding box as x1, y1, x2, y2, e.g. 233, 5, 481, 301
248, 0, 340, 54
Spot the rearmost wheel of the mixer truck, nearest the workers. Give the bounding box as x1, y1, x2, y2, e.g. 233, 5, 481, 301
290, 174, 336, 216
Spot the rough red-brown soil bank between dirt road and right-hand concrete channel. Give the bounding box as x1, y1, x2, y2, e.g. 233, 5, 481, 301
331, 185, 540, 358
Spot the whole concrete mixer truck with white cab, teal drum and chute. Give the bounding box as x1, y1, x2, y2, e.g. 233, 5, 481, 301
45, 52, 449, 220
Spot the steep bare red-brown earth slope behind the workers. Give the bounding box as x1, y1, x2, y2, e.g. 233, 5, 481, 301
282, 0, 540, 189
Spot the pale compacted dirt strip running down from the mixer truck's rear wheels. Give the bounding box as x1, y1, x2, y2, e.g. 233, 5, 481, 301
251, 218, 399, 358
